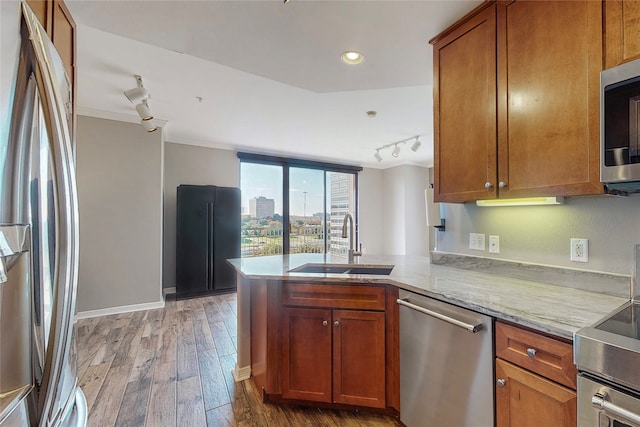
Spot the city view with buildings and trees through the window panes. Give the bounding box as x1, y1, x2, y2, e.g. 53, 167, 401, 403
240, 163, 356, 257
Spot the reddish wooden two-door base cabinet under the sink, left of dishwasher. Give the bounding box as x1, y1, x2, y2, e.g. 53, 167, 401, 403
251, 281, 400, 416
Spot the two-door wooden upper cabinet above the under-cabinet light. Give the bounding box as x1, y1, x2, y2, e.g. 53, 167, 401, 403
432, 0, 603, 202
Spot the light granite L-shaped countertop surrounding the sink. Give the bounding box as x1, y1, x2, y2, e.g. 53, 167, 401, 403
228, 254, 630, 339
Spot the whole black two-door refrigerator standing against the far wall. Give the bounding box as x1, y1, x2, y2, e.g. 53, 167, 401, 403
176, 185, 240, 298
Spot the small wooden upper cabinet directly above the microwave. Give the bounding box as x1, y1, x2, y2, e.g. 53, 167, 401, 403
603, 0, 640, 68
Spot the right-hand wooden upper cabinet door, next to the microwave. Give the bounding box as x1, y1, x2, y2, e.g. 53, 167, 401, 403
498, 1, 603, 198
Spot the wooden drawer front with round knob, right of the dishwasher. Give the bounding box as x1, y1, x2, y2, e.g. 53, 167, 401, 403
496, 322, 577, 390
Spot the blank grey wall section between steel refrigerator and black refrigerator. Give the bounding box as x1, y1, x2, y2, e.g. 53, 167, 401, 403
77, 116, 163, 312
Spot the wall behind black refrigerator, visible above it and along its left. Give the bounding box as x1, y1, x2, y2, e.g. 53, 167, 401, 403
162, 142, 240, 288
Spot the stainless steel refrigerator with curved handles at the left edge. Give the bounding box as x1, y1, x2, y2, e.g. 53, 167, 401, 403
0, 1, 87, 427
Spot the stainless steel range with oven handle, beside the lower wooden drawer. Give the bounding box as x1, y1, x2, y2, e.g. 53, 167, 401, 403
574, 301, 640, 427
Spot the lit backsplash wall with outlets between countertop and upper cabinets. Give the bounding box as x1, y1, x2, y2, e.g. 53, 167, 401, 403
438, 195, 640, 275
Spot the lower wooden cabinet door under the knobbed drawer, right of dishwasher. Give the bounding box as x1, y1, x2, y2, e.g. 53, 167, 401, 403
496, 359, 577, 427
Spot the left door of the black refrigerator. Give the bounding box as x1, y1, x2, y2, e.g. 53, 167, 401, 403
176, 185, 216, 296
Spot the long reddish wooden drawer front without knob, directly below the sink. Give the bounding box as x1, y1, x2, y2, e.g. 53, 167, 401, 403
282, 283, 385, 311
